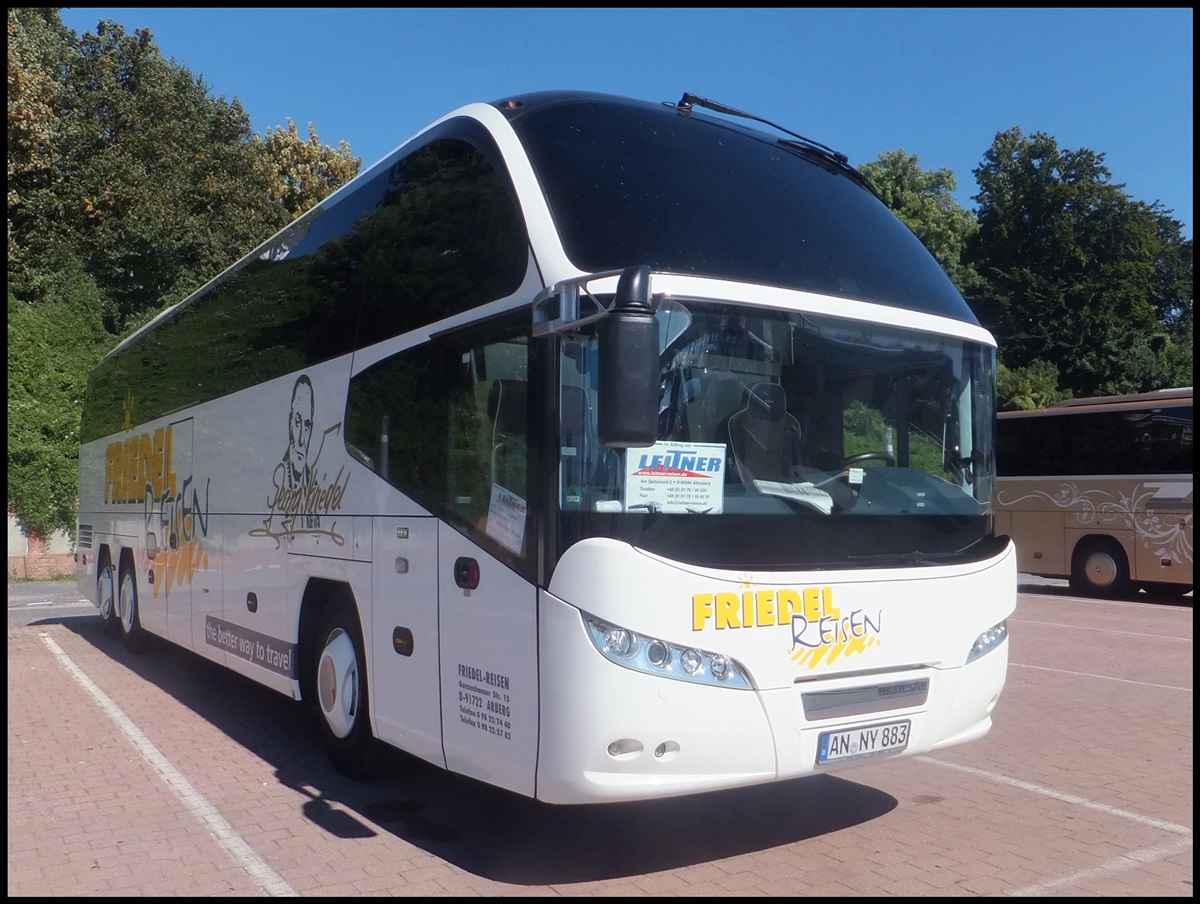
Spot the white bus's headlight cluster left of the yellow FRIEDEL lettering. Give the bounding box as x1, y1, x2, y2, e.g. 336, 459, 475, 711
582, 612, 754, 690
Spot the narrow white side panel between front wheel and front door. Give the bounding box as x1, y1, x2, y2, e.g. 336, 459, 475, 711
368, 517, 445, 766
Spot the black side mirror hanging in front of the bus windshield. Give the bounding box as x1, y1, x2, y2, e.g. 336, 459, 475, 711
596, 265, 660, 448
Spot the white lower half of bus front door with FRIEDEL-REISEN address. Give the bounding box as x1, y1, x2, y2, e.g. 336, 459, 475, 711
438, 521, 538, 797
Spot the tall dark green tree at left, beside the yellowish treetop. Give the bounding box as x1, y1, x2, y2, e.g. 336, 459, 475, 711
13, 22, 290, 333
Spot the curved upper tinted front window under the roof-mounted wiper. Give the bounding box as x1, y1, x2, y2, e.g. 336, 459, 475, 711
511, 96, 977, 323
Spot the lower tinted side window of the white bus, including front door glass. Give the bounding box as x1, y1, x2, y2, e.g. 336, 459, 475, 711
346, 313, 538, 576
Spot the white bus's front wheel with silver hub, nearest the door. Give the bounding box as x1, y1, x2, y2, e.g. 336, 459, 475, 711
313, 587, 378, 778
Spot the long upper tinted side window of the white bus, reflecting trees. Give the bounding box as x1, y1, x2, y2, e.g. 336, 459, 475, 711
83, 122, 529, 442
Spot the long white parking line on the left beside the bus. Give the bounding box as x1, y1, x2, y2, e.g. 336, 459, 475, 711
38, 634, 300, 898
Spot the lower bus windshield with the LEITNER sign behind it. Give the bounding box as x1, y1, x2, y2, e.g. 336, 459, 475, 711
558, 300, 995, 568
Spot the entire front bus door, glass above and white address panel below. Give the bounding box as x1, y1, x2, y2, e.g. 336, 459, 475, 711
438, 328, 541, 796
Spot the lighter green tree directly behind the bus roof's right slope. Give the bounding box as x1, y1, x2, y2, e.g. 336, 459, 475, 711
858, 148, 979, 294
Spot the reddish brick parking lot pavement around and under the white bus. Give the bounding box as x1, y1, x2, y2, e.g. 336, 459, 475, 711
8, 594, 1193, 897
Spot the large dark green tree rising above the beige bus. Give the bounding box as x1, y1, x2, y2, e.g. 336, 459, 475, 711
965, 127, 1190, 396
